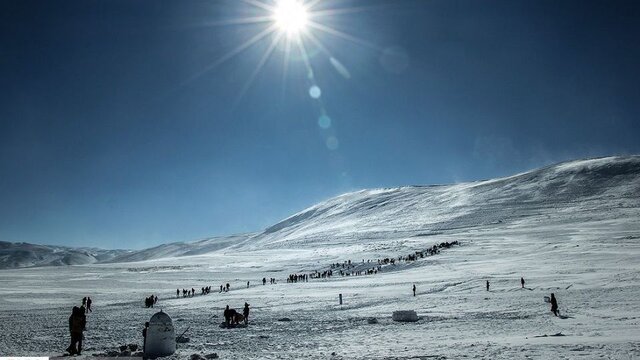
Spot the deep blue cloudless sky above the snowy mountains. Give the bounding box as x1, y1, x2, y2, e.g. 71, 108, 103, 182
0, 0, 640, 248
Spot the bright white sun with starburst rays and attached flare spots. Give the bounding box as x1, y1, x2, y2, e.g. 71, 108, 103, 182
195, 0, 382, 107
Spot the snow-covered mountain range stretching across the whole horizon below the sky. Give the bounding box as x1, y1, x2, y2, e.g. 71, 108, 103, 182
0, 156, 640, 269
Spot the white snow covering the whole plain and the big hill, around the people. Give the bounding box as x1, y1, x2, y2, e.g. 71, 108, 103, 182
0, 156, 640, 359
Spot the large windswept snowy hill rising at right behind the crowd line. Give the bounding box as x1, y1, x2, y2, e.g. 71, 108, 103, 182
254, 156, 640, 247
